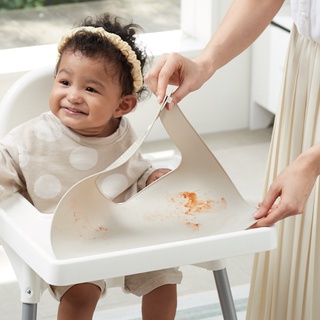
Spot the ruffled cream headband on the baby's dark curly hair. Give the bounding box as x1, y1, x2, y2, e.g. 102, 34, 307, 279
58, 27, 143, 92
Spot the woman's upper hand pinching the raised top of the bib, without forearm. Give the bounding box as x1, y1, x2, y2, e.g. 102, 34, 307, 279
145, 53, 207, 109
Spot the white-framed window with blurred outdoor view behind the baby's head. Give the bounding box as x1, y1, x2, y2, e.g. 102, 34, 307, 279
0, 0, 215, 75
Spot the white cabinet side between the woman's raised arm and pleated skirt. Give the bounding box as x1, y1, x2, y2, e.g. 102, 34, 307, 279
249, 3, 293, 129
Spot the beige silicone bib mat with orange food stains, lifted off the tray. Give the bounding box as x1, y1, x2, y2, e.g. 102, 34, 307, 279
51, 98, 255, 259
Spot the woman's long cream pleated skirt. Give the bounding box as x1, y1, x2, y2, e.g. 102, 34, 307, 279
247, 27, 320, 320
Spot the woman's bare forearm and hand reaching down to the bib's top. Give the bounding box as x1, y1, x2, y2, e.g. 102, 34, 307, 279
145, 0, 283, 106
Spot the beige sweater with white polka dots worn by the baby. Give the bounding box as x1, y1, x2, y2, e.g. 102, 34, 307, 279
0, 112, 152, 213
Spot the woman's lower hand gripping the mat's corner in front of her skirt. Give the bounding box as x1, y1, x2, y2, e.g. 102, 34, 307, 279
254, 149, 319, 227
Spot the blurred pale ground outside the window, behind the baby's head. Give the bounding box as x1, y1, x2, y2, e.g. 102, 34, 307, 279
0, 0, 180, 50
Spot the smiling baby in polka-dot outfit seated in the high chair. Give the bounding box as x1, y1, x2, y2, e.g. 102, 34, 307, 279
0, 14, 182, 320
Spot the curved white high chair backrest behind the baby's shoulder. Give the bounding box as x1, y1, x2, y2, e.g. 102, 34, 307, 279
0, 65, 54, 138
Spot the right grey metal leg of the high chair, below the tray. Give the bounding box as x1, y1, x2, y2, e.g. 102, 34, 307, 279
213, 268, 238, 320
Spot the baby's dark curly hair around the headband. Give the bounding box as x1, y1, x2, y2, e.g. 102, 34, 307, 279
56, 13, 150, 101
